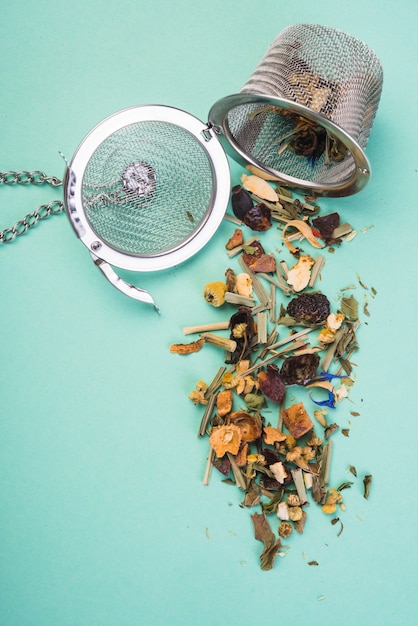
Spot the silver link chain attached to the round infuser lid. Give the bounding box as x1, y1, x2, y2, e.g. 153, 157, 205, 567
0, 170, 64, 243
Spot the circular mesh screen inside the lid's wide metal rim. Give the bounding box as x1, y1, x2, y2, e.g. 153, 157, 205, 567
82, 121, 214, 256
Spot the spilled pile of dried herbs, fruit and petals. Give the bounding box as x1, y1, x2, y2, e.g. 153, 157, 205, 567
170, 175, 371, 570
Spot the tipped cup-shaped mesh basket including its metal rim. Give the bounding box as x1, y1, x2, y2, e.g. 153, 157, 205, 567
209, 24, 383, 195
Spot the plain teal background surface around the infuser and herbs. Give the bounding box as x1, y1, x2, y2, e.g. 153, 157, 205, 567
0, 0, 418, 626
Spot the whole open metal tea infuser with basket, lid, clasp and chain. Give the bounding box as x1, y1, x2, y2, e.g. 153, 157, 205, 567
0, 24, 383, 308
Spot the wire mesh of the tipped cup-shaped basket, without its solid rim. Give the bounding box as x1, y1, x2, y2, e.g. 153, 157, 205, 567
228, 24, 383, 184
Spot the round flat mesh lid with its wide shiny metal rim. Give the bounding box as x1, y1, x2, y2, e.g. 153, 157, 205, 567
65, 105, 231, 271
